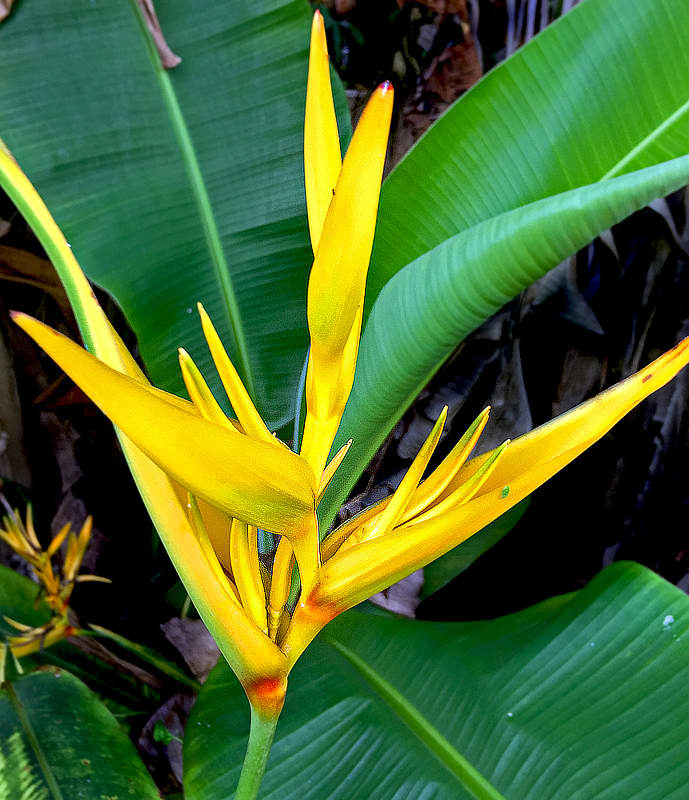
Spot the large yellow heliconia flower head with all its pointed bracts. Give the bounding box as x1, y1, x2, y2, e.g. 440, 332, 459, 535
0, 12, 689, 720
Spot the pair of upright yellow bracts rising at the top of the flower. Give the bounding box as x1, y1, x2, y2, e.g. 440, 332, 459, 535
301, 12, 393, 476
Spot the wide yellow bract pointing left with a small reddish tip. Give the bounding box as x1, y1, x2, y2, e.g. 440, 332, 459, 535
13, 314, 315, 536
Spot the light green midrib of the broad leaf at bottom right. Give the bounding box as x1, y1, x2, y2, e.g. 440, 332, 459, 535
323, 635, 505, 800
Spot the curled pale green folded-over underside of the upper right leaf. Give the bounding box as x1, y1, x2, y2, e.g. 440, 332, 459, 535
320, 156, 689, 520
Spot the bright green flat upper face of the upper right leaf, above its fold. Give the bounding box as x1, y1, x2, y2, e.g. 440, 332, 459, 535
367, 0, 689, 309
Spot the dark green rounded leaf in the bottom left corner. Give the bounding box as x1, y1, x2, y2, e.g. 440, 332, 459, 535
0, 668, 160, 800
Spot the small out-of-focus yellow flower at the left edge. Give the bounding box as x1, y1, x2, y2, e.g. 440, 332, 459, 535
0, 504, 110, 658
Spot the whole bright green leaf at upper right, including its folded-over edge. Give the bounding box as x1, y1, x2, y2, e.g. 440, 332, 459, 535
322, 0, 689, 521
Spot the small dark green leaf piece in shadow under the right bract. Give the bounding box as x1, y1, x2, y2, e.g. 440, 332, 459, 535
421, 497, 530, 600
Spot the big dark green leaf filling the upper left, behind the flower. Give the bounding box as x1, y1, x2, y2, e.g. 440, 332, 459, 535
0, 0, 349, 427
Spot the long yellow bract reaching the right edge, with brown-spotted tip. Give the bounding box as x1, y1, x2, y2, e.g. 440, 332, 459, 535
310, 337, 689, 620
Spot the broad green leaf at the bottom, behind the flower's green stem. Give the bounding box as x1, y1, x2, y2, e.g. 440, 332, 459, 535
184, 563, 689, 800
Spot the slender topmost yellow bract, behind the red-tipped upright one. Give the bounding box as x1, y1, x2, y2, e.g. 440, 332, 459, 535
304, 11, 342, 254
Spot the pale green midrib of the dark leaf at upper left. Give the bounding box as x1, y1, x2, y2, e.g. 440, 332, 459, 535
130, 0, 256, 400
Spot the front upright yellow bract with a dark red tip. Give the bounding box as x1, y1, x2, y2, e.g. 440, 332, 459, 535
302, 83, 393, 476
